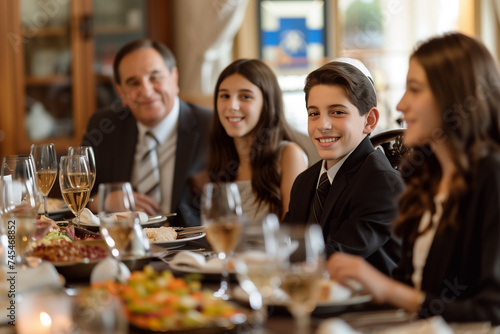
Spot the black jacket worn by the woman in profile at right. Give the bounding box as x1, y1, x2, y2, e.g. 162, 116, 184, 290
394, 153, 500, 325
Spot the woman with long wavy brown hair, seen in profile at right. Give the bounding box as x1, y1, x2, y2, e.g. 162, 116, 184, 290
328, 33, 500, 324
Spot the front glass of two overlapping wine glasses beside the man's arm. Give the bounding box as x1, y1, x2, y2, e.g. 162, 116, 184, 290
59, 155, 90, 227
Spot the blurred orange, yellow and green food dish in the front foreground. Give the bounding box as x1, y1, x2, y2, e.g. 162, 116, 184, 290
96, 266, 247, 333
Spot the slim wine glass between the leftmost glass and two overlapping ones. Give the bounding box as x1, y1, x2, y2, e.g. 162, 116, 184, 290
31, 144, 57, 218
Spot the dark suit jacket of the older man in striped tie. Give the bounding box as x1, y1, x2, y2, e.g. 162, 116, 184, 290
82, 101, 212, 226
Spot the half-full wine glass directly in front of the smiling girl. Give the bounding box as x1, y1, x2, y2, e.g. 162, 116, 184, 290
201, 183, 244, 299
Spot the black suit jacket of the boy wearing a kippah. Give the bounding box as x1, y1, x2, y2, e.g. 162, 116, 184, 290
283, 137, 404, 275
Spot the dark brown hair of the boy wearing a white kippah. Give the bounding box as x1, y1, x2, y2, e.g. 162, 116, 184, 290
304, 61, 377, 115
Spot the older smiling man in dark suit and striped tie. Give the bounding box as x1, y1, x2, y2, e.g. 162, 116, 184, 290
82, 40, 212, 226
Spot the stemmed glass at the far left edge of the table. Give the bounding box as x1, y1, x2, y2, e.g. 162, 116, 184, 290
1, 155, 42, 269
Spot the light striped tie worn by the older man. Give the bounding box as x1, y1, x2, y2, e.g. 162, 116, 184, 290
136, 131, 161, 203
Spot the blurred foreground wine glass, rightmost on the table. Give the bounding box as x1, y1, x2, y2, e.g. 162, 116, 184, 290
278, 224, 325, 333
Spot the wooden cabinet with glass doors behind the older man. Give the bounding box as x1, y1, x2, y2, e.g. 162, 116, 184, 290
0, 0, 172, 156
